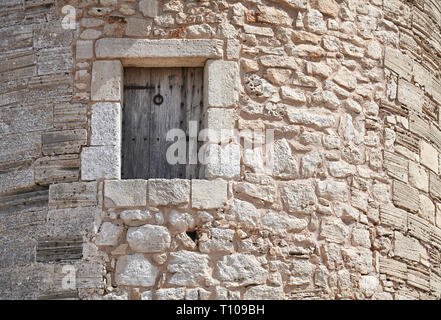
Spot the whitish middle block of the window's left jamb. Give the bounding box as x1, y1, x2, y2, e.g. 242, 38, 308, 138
90, 102, 122, 146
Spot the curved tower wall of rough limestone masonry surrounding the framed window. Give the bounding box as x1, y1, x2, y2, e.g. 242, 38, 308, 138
0, 0, 441, 299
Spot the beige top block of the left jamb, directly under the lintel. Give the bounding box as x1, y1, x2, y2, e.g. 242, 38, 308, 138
91, 60, 124, 102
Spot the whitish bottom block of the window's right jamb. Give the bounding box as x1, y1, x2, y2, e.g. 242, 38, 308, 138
204, 143, 240, 179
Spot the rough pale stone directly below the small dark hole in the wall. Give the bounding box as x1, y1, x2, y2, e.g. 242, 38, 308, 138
167, 250, 211, 287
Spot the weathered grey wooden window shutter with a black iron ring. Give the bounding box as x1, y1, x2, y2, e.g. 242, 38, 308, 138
121, 68, 203, 179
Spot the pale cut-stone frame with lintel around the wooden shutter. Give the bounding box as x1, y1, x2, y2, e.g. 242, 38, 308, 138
81, 38, 240, 181
